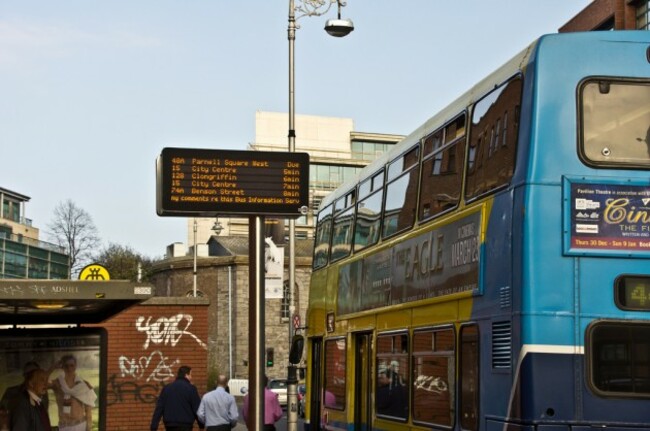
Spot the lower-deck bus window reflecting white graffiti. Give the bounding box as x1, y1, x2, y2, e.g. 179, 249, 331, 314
413, 328, 456, 427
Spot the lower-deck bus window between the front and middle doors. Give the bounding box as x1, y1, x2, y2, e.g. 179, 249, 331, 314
323, 338, 346, 410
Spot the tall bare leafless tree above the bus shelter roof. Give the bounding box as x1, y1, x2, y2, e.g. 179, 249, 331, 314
48, 199, 100, 275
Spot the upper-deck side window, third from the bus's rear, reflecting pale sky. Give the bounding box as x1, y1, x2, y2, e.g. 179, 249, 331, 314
382, 145, 420, 238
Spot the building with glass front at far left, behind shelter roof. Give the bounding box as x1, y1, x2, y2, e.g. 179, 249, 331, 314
0, 187, 70, 279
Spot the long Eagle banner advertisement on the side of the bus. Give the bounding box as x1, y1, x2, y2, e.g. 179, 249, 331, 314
337, 208, 482, 314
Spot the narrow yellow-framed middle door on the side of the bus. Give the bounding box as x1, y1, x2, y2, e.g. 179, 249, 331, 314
353, 332, 373, 431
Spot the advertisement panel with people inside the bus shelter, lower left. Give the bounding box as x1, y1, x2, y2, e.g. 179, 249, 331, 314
0, 328, 105, 431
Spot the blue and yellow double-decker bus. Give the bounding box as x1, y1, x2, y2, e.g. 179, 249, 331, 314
306, 31, 650, 431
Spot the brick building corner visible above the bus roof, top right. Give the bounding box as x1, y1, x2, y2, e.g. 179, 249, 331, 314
558, 0, 650, 33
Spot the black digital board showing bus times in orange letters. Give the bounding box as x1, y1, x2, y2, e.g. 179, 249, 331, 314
156, 148, 309, 218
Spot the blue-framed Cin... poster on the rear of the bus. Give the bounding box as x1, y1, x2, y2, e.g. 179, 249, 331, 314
565, 181, 650, 257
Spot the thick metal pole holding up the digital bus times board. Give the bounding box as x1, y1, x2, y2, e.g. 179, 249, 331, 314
248, 216, 265, 431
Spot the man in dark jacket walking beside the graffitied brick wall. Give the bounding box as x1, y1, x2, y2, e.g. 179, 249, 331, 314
150, 365, 203, 431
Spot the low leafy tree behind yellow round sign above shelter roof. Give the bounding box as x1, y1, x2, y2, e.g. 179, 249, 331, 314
95, 243, 153, 281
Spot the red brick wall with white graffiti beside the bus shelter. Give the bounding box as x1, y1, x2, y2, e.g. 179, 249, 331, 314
87, 297, 209, 431
